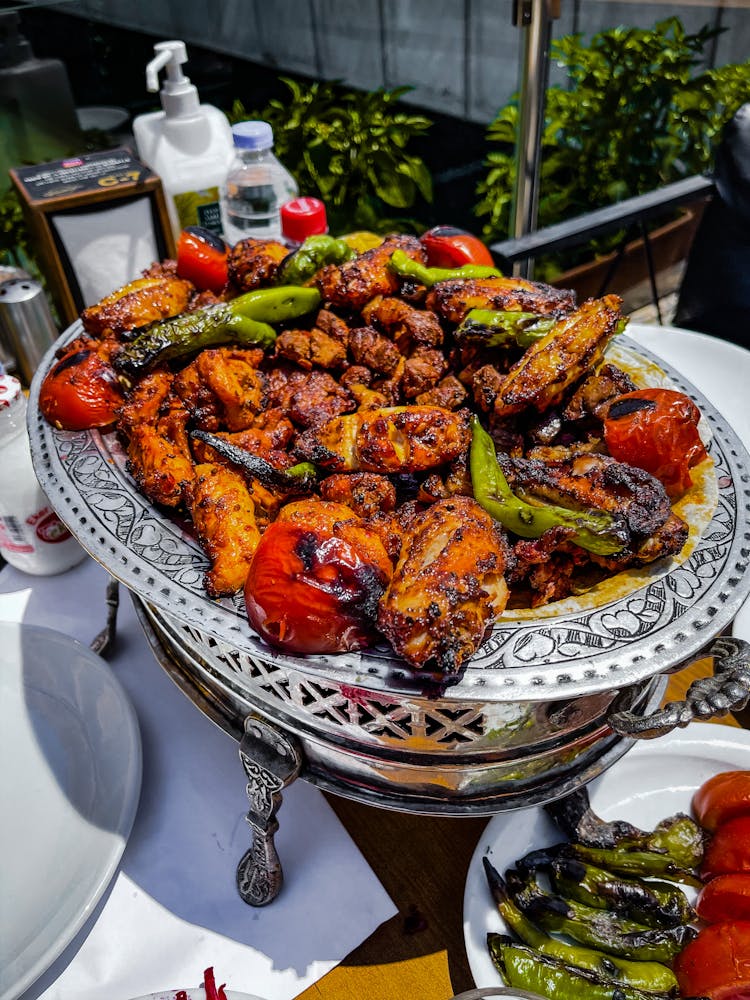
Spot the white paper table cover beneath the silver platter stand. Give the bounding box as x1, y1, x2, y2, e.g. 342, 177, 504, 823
0, 559, 396, 1000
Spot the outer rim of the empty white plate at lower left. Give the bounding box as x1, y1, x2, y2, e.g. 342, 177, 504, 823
0, 621, 143, 1000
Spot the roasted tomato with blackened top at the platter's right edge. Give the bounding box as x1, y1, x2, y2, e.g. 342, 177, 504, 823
604, 389, 707, 497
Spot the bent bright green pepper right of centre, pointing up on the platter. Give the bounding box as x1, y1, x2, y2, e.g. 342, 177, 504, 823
469, 417, 629, 555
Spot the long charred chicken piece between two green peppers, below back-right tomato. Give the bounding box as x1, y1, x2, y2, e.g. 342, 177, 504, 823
425, 278, 575, 323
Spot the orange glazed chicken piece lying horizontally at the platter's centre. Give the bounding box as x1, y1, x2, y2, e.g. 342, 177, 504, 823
294, 406, 471, 473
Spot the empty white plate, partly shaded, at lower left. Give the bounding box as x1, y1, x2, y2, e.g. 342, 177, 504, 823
0, 622, 141, 1000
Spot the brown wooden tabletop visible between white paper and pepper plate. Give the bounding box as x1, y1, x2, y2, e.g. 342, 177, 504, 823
300, 660, 739, 1000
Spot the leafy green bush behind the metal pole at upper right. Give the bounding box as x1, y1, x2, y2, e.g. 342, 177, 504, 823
476, 17, 750, 277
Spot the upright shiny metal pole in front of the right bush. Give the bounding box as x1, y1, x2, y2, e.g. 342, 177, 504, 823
510, 0, 560, 277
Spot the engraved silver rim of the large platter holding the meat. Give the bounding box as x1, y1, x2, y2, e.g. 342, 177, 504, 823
29, 323, 750, 703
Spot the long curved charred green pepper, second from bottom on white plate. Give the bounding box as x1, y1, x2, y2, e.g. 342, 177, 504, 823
483, 858, 678, 992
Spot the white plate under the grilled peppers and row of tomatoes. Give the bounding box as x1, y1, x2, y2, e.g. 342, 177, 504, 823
464, 722, 750, 986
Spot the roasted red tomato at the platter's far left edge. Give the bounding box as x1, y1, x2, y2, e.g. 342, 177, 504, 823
39, 341, 123, 431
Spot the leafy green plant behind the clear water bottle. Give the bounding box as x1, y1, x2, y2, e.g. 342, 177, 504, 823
230, 77, 432, 233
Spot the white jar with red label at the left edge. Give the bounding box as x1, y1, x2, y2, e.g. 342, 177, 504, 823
0, 368, 86, 576
